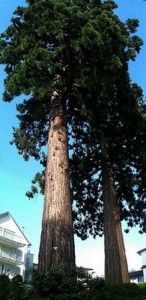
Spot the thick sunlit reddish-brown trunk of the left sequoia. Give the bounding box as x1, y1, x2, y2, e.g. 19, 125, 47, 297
39, 91, 75, 271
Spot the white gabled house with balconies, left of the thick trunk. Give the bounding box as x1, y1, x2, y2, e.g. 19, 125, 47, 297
0, 212, 33, 282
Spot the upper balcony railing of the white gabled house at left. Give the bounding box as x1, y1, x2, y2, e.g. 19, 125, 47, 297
0, 227, 24, 246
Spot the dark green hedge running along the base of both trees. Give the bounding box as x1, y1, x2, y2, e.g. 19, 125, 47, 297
0, 268, 146, 300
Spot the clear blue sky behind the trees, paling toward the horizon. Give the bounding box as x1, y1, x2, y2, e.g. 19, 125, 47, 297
0, 0, 146, 275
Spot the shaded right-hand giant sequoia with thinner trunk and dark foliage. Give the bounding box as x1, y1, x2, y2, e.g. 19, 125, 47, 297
71, 24, 146, 282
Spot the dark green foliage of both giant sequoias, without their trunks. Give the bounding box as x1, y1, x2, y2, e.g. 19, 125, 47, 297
0, 0, 146, 239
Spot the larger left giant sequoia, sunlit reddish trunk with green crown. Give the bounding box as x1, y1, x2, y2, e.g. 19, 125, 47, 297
1, 0, 105, 271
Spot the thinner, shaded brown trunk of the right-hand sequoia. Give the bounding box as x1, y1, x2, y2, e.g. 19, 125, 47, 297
101, 135, 129, 283
